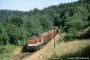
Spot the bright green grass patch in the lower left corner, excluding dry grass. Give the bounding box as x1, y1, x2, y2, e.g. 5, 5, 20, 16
0, 45, 17, 60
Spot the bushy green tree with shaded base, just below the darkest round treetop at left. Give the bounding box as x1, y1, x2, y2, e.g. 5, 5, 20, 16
5, 24, 21, 44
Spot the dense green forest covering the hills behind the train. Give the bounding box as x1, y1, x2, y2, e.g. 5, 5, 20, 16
0, 0, 90, 46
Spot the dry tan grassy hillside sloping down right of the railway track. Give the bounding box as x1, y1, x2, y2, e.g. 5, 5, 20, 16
23, 35, 90, 60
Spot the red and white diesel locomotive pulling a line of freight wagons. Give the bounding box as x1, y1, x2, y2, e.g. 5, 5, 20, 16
26, 26, 59, 51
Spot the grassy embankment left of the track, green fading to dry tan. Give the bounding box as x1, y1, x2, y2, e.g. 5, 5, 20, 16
0, 45, 22, 60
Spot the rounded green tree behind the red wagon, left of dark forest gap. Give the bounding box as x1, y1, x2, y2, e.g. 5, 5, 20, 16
40, 14, 54, 31
